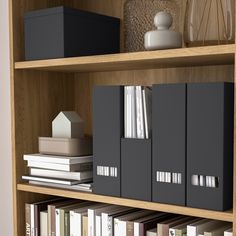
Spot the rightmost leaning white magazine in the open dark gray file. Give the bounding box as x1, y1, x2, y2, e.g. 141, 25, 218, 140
142, 87, 152, 139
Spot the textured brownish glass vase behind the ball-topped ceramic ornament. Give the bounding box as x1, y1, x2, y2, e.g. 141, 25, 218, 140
124, 0, 185, 52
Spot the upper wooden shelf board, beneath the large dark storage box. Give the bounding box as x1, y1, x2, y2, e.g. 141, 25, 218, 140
15, 44, 236, 72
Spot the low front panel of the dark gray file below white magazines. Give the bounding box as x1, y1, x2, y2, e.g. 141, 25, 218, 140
121, 138, 152, 201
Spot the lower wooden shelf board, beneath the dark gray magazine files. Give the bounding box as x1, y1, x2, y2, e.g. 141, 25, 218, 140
17, 184, 233, 222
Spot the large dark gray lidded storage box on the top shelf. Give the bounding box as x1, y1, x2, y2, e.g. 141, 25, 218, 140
24, 6, 120, 60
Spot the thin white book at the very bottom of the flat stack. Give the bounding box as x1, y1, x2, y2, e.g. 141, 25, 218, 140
29, 180, 92, 192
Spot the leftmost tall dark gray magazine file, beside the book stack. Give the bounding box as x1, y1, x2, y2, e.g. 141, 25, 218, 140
93, 86, 124, 197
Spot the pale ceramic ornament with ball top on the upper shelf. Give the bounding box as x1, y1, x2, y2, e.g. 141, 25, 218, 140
144, 11, 182, 50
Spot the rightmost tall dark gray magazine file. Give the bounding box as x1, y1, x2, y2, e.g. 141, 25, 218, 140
187, 83, 234, 211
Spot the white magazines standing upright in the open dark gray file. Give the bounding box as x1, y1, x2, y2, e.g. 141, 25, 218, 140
124, 86, 152, 139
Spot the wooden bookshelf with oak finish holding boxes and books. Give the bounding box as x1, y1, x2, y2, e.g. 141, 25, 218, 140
9, 0, 236, 236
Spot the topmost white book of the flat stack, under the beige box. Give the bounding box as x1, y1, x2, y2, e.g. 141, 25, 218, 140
24, 153, 93, 165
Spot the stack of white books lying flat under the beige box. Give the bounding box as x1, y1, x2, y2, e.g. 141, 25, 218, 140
22, 154, 93, 192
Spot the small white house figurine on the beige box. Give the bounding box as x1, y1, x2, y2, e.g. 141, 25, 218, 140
52, 111, 84, 138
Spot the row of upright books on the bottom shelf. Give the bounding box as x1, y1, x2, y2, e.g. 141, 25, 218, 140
25, 198, 233, 236
